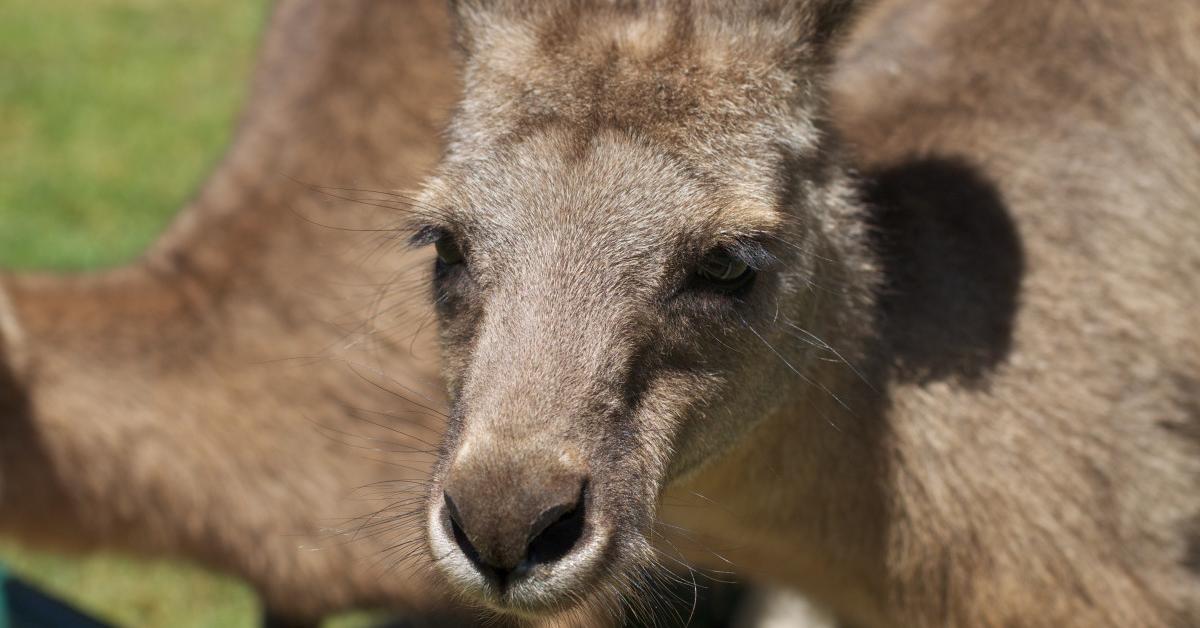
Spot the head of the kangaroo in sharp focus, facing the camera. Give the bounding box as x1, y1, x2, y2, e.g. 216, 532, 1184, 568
414, 1, 866, 612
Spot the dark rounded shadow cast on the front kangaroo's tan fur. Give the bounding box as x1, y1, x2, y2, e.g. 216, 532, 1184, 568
865, 156, 1026, 385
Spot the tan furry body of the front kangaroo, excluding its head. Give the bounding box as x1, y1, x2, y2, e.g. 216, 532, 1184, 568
679, 1, 1200, 626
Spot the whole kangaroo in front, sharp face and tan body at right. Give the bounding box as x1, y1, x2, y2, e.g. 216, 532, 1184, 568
408, 0, 1200, 627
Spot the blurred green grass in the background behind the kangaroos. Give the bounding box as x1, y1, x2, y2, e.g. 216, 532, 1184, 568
0, 0, 374, 627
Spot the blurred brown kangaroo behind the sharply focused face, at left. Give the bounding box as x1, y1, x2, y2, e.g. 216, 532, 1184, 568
0, 0, 470, 622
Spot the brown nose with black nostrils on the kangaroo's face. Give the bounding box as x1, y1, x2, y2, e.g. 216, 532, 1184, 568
444, 465, 587, 591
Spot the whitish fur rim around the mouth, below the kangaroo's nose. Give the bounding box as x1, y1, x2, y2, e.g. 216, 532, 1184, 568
427, 504, 611, 615
